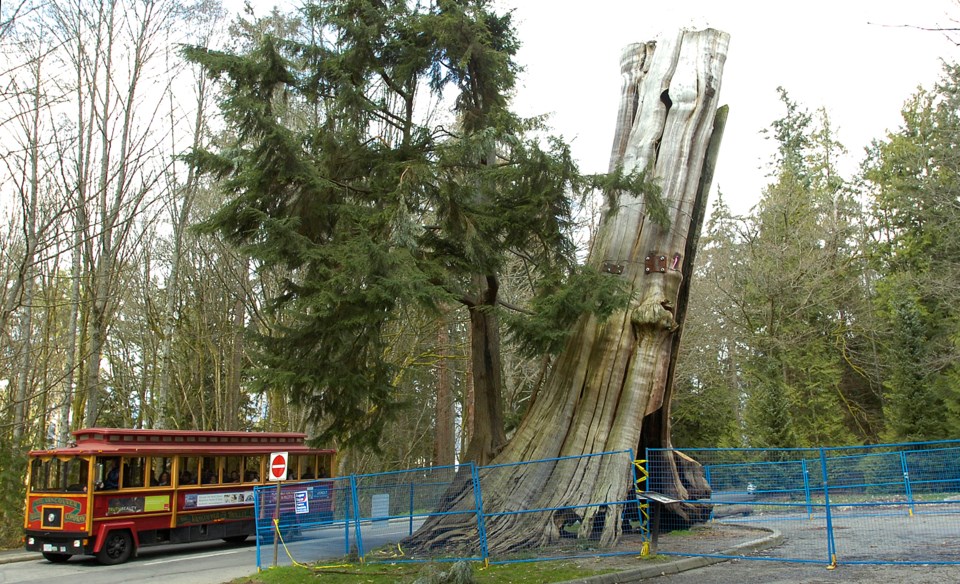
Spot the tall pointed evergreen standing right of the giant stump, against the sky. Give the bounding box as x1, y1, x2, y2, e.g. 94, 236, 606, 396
741, 89, 871, 447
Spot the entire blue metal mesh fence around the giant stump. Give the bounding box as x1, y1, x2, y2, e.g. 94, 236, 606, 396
255, 441, 960, 566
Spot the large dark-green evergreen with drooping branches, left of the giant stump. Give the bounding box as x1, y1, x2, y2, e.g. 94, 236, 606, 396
185, 0, 645, 454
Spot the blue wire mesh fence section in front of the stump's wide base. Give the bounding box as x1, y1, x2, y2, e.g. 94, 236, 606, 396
255, 451, 645, 567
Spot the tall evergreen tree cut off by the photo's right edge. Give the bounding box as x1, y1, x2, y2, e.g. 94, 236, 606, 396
864, 65, 960, 440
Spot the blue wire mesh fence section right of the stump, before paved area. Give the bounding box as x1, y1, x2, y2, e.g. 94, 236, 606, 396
647, 442, 960, 564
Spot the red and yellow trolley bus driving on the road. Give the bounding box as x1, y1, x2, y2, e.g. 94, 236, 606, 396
24, 428, 335, 564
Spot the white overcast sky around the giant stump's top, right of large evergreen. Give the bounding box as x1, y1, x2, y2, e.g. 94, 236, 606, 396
501, 0, 960, 213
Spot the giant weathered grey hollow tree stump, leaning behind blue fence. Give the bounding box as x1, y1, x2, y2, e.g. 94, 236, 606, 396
408, 29, 729, 554
